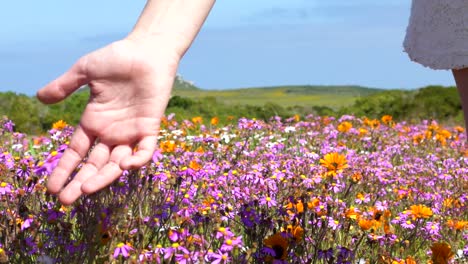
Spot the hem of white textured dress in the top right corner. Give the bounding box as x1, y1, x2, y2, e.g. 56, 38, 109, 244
403, 0, 468, 70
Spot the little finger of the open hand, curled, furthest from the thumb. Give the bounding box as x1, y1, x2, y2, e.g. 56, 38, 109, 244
120, 136, 158, 170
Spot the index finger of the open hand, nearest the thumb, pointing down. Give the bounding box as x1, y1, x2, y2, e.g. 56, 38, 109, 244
47, 126, 94, 193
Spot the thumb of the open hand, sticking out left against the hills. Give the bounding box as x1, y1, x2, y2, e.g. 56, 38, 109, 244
37, 57, 89, 104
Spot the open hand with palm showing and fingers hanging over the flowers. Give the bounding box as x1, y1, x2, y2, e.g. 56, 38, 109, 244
37, 38, 181, 205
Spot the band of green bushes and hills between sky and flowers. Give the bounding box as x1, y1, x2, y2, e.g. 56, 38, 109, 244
0, 84, 463, 134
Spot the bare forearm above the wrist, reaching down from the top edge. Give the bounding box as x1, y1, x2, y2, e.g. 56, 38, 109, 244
129, 0, 216, 57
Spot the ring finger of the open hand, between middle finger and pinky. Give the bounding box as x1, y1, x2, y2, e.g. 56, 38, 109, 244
81, 146, 132, 194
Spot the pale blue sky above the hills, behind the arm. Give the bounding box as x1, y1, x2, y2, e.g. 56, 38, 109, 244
0, 0, 454, 95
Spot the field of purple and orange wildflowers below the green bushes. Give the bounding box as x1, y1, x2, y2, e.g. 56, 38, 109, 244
0, 115, 468, 264
